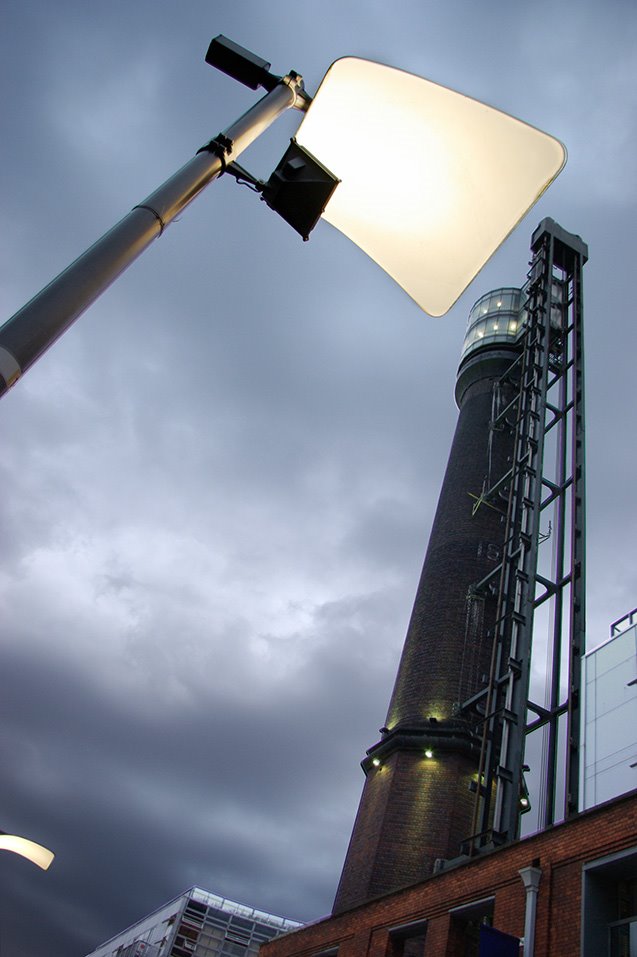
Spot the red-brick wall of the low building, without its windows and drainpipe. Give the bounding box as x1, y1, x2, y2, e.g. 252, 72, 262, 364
260, 791, 637, 957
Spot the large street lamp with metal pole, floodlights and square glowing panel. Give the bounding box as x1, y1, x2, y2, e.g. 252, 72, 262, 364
0, 37, 566, 395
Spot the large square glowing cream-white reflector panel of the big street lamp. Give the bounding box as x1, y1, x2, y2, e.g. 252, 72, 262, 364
296, 57, 566, 316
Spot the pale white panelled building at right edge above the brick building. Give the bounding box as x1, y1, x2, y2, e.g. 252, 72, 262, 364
580, 609, 637, 808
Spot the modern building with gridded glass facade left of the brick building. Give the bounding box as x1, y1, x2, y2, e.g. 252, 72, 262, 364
87, 887, 302, 957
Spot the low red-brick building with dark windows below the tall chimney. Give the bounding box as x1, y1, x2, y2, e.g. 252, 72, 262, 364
260, 791, 637, 957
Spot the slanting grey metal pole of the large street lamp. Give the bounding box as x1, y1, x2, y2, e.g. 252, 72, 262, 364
0, 73, 309, 396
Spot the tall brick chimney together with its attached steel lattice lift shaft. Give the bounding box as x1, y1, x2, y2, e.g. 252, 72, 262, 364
334, 220, 587, 913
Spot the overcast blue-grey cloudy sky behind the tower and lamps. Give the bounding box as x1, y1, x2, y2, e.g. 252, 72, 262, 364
0, 0, 637, 957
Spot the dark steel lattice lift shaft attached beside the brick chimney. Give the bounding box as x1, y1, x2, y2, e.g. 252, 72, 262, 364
461, 219, 588, 855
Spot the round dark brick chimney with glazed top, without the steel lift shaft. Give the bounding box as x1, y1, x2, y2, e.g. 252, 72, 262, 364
333, 288, 523, 914
